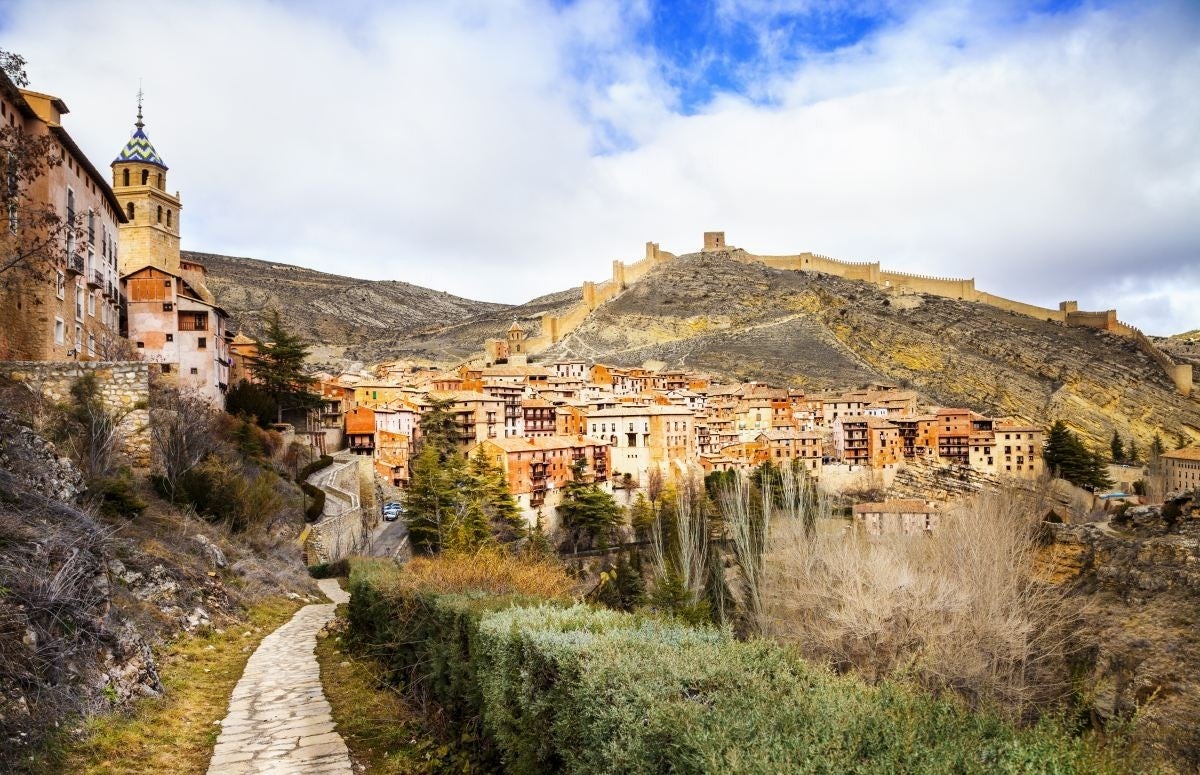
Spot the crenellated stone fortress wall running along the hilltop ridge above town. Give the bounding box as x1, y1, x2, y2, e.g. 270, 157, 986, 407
528, 232, 1193, 396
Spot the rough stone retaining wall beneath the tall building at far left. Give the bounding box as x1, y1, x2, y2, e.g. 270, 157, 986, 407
0, 361, 150, 468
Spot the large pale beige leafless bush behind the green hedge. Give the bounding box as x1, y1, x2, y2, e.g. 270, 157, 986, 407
762, 492, 1078, 717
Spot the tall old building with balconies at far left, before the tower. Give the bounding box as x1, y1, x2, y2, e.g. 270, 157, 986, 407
0, 73, 125, 361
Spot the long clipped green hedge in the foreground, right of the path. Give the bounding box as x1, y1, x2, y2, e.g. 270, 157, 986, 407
349, 560, 1115, 773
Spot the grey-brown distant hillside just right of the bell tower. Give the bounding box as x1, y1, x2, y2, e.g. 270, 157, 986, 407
182, 251, 508, 358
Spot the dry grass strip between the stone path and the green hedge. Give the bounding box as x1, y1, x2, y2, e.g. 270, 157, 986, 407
317, 609, 450, 775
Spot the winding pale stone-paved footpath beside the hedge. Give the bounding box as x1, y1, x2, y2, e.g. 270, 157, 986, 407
209, 578, 354, 775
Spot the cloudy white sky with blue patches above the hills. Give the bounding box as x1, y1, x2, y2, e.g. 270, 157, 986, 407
0, 0, 1200, 335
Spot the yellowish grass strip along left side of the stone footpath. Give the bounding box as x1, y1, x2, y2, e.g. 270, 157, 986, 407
18, 597, 301, 775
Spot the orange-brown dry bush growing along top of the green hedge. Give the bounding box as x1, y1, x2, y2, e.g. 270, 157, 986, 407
396, 547, 576, 599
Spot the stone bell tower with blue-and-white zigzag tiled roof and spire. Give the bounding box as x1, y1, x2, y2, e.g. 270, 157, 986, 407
113, 92, 181, 275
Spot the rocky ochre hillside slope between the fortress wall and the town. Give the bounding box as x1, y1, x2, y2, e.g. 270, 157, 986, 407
542, 253, 1200, 450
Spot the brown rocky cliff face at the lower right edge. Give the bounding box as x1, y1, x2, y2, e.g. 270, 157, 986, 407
1040, 499, 1200, 771
